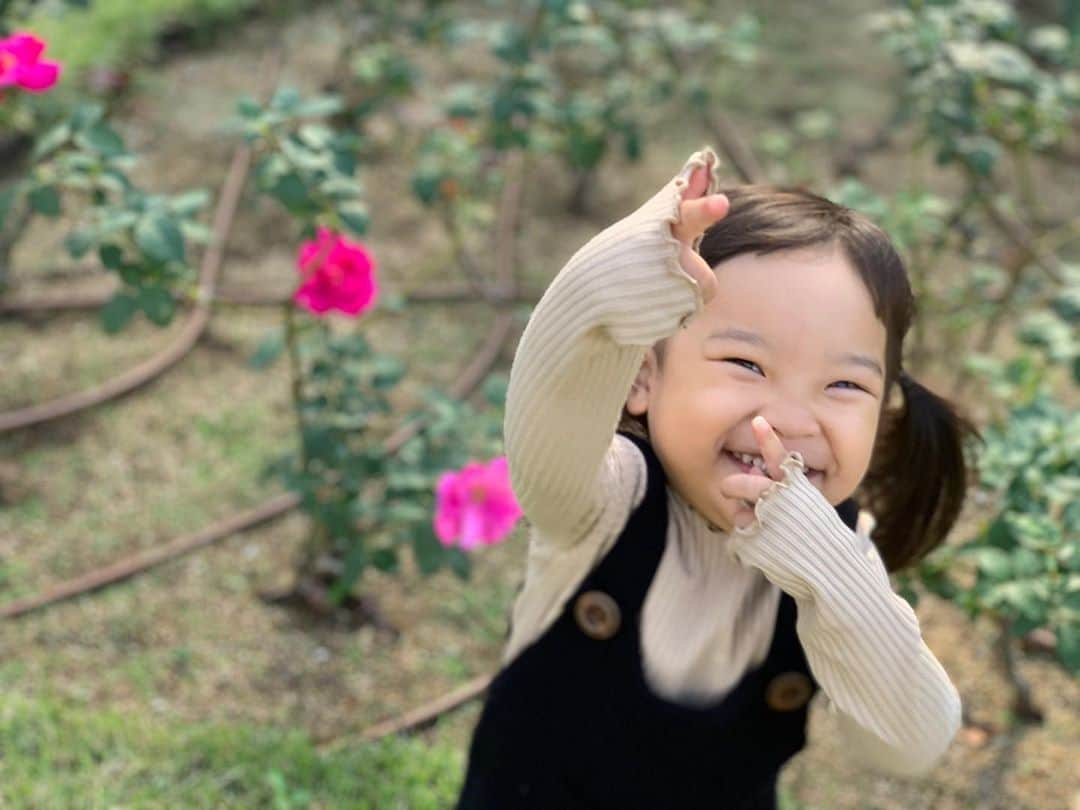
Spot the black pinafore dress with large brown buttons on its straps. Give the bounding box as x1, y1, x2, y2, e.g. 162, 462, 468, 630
457, 434, 859, 810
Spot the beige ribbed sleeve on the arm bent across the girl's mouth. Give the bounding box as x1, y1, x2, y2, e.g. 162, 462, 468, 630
730, 453, 960, 773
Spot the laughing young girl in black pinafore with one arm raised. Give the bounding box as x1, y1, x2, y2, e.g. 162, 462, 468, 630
459, 149, 973, 810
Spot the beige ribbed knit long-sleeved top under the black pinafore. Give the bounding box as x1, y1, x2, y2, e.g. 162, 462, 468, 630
503, 150, 960, 773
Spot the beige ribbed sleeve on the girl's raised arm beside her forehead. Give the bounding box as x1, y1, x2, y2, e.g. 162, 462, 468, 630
504, 150, 716, 544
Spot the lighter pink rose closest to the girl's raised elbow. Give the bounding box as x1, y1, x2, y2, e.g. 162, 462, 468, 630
434, 456, 522, 551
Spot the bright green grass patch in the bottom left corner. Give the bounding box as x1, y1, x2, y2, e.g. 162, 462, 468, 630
0, 693, 463, 810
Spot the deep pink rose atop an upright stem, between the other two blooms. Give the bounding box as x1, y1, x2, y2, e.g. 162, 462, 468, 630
293, 228, 379, 315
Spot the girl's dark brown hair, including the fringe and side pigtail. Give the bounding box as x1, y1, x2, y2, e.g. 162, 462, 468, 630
619, 185, 981, 571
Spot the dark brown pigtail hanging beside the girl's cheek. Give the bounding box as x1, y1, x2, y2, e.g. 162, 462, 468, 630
861, 372, 982, 571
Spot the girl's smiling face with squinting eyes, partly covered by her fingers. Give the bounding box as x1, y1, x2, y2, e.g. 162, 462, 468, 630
626, 245, 886, 531
